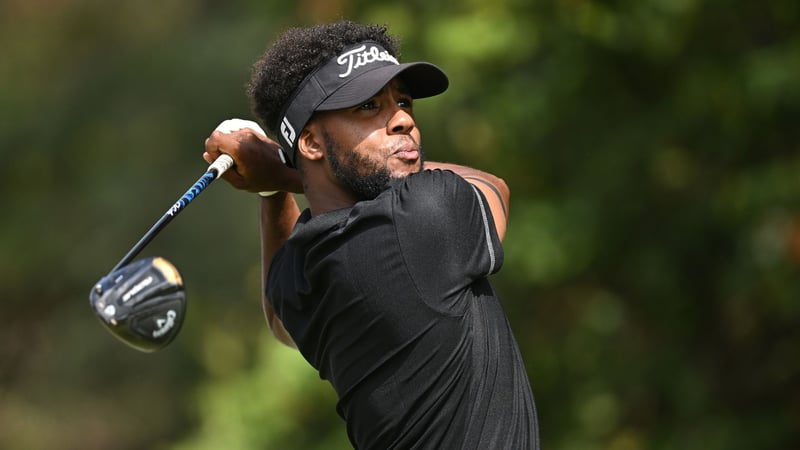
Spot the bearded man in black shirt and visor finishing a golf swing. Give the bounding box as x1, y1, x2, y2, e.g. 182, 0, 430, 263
204, 22, 539, 450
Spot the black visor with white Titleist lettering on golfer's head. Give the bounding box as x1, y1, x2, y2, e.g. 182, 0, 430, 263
276, 41, 449, 165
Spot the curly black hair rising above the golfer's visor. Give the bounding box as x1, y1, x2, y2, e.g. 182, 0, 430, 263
247, 21, 400, 136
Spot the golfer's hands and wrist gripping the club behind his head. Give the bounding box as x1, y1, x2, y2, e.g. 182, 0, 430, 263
203, 119, 303, 193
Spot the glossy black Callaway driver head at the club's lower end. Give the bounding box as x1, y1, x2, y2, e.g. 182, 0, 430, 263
89, 257, 186, 353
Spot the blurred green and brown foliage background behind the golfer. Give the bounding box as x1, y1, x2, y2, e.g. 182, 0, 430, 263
0, 0, 800, 450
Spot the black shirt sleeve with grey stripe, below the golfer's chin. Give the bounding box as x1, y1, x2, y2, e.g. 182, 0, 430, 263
392, 170, 503, 304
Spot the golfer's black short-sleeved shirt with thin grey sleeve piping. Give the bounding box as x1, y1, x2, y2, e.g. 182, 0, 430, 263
267, 170, 538, 450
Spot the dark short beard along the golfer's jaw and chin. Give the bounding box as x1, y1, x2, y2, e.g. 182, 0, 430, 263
322, 131, 424, 201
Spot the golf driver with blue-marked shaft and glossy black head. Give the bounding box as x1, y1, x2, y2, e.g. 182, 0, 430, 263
89, 154, 233, 352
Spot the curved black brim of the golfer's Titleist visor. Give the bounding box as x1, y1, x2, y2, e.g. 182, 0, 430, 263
316, 62, 450, 111
